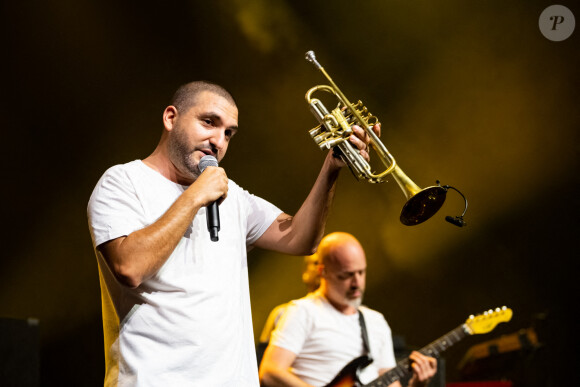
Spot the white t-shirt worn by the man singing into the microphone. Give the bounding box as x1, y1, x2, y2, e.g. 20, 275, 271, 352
88, 160, 281, 387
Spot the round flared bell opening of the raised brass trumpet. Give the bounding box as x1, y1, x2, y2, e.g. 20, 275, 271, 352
400, 186, 447, 226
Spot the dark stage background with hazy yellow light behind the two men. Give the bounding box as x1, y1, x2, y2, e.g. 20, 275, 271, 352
0, 0, 580, 386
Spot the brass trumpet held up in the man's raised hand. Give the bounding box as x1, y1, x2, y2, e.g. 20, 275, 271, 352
306, 51, 467, 227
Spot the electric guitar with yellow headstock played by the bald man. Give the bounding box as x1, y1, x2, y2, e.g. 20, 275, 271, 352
327, 306, 513, 387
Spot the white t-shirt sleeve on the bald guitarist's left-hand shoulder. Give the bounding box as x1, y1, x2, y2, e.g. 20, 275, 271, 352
270, 301, 310, 355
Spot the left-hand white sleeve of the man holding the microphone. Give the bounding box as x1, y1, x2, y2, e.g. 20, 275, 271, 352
87, 167, 146, 247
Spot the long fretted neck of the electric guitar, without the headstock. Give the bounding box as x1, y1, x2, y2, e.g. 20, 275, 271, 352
364, 324, 470, 387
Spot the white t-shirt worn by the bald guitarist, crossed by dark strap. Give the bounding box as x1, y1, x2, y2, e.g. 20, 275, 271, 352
270, 291, 396, 386
